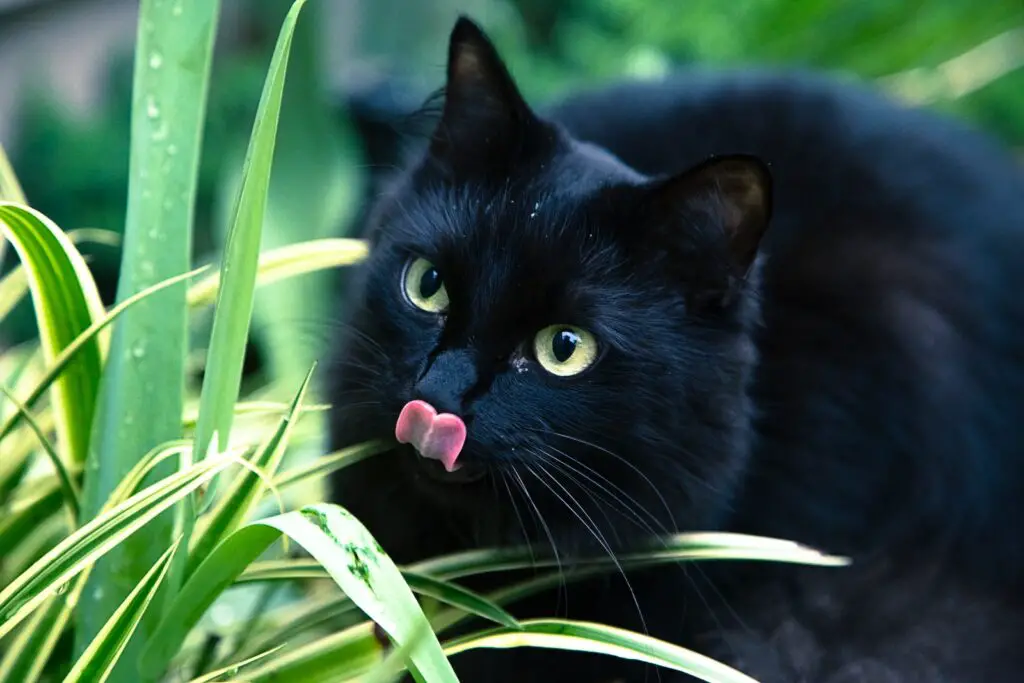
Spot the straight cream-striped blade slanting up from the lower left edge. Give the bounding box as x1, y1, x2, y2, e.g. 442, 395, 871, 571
0, 448, 237, 638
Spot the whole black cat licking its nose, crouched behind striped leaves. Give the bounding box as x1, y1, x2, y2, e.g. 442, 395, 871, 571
329, 18, 1024, 683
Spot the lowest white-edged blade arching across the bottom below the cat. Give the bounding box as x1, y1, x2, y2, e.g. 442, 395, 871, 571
444, 620, 757, 683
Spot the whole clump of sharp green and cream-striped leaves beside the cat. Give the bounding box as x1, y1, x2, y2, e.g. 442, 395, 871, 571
0, 0, 841, 683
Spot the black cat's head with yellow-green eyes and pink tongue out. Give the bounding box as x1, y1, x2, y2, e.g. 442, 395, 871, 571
328, 18, 771, 552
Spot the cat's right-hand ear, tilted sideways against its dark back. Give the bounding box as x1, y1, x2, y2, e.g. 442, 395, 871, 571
649, 155, 772, 279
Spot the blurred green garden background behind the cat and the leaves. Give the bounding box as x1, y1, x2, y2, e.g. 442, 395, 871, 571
0, 0, 1024, 393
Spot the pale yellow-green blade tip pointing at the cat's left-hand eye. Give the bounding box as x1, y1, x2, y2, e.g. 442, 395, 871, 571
185, 238, 369, 306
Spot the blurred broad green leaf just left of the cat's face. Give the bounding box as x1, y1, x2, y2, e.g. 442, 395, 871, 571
239, 0, 366, 383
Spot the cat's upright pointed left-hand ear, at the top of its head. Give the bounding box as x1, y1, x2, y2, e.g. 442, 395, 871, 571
431, 15, 535, 156
